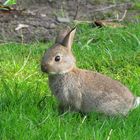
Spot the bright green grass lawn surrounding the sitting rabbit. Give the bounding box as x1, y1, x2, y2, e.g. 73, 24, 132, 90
0, 24, 140, 140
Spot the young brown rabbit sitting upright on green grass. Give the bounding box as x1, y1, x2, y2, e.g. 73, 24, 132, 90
41, 28, 140, 115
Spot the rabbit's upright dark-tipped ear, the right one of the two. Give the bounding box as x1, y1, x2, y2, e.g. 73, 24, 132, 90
61, 27, 76, 50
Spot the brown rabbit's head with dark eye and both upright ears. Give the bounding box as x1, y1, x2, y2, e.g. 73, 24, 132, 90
41, 28, 76, 74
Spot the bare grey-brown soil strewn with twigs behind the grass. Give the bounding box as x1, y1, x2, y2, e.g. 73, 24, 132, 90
0, 0, 138, 43
